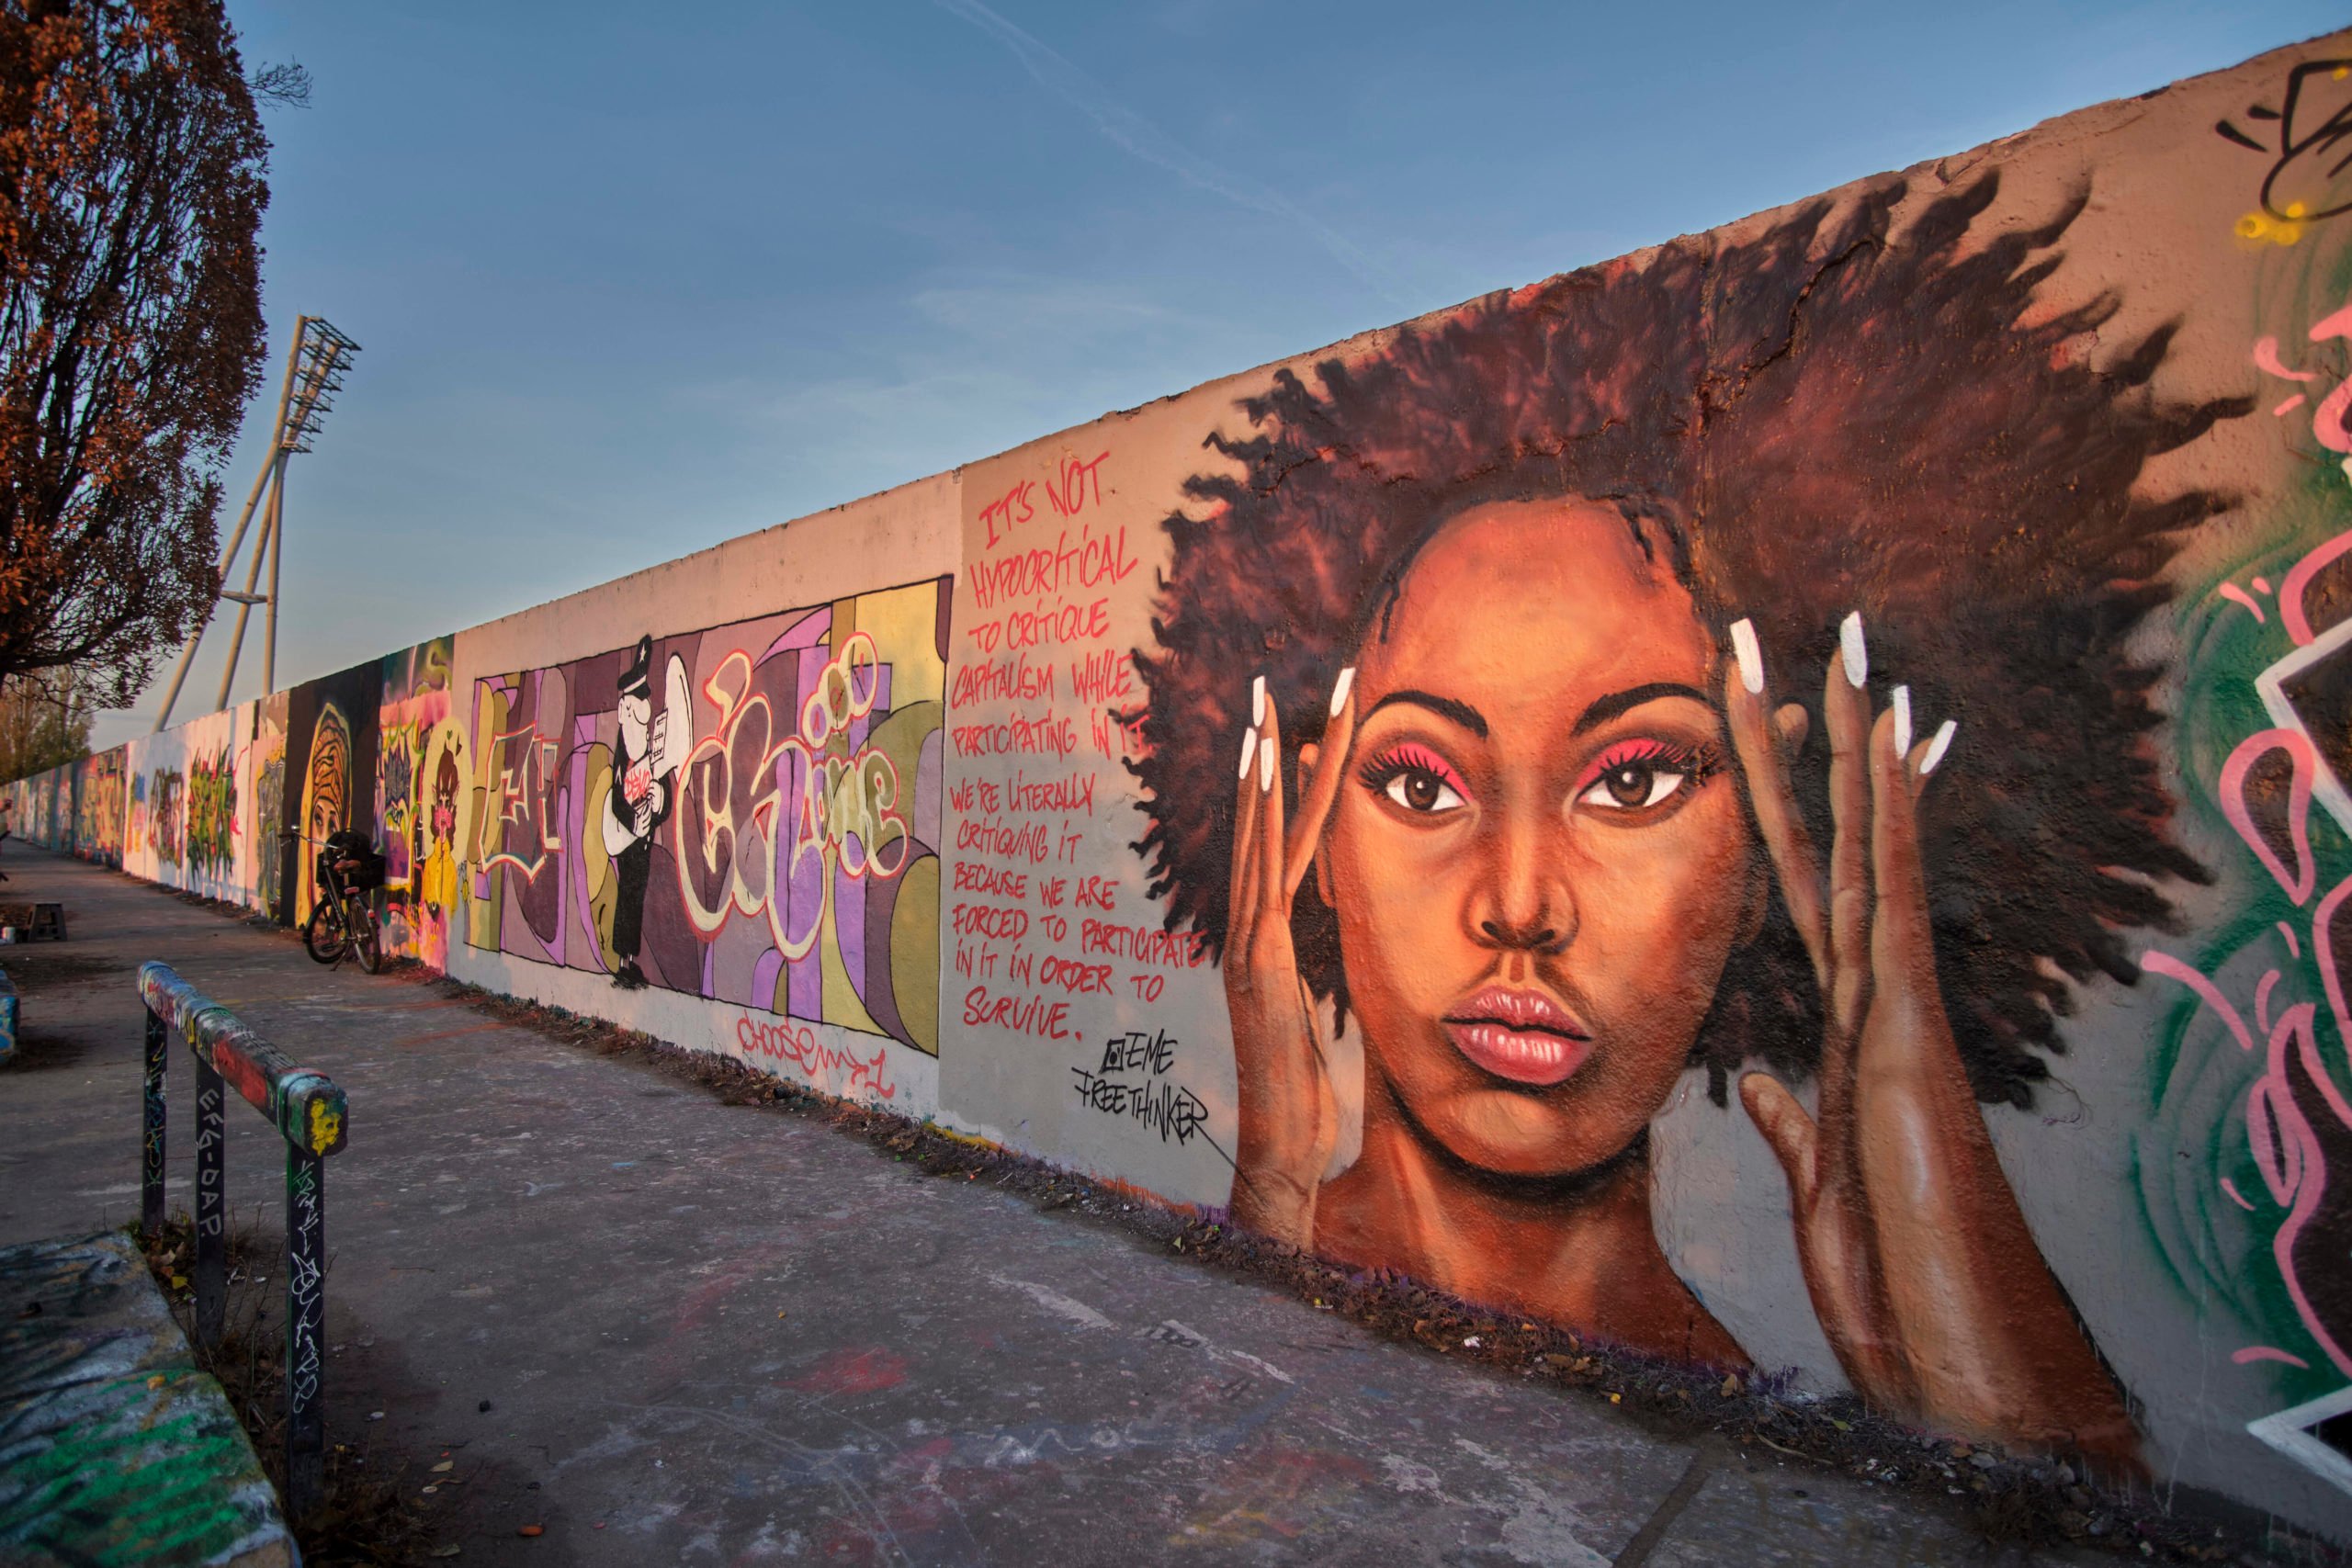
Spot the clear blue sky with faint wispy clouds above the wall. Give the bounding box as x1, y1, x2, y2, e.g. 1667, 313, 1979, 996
110, 0, 2343, 745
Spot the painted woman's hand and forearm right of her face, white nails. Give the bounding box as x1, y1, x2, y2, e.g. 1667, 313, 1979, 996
1724, 616, 2138, 1460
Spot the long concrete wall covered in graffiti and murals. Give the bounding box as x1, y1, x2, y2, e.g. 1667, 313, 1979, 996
12, 35, 2352, 1538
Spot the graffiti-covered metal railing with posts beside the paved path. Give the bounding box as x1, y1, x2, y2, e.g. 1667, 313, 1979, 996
139, 964, 345, 1518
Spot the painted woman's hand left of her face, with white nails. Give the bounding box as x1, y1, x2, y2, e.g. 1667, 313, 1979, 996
1226, 668, 1355, 1248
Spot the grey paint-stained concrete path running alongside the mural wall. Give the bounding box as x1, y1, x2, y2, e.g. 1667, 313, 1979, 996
0, 851, 2114, 1568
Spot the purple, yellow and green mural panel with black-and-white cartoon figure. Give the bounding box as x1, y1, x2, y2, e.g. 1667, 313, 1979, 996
468, 581, 950, 1055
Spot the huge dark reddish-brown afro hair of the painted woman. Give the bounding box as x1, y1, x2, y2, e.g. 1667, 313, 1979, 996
1134, 174, 2251, 1105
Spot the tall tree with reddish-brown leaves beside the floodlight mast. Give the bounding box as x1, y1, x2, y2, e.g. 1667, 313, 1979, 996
0, 0, 272, 705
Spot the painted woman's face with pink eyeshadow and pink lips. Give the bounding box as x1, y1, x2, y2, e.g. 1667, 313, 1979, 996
1317, 499, 1767, 1178
